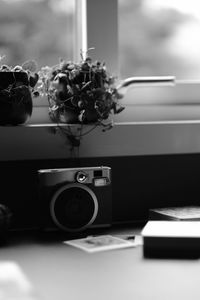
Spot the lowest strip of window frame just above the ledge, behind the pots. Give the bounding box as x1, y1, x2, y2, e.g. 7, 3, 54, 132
26, 104, 200, 127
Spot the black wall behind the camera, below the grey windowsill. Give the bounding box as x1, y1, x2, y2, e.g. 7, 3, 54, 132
0, 154, 200, 227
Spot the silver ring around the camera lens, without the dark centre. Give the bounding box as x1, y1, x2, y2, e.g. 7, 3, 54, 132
50, 183, 98, 232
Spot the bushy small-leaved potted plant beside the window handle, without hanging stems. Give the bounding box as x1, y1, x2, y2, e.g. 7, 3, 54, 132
39, 52, 124, 124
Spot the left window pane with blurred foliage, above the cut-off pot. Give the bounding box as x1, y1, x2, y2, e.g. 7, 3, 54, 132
0, 0, 75, 68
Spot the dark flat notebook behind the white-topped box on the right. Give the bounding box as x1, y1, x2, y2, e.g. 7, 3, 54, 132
149, 206, 200, 221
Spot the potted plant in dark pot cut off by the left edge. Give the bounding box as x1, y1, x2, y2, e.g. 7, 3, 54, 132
0, 57, 39, 125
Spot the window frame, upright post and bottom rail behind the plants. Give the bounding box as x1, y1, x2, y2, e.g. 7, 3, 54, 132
31, 0, 200, 123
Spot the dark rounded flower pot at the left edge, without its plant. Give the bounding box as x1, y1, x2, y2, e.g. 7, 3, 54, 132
0, 72, 33, 125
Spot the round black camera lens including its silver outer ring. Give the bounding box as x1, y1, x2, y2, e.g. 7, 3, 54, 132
50, 183, 98, 232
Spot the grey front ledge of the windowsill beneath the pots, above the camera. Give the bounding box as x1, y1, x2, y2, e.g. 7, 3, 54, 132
0, 110, 200, 160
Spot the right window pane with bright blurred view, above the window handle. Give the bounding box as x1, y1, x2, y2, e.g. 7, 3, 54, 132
118, 0, 200, 79
